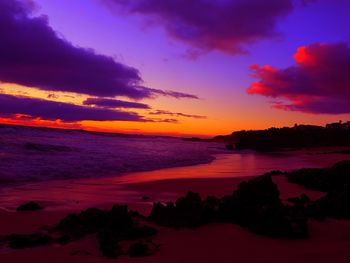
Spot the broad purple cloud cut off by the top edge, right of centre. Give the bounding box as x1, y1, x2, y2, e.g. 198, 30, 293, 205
101, 0, 293, 55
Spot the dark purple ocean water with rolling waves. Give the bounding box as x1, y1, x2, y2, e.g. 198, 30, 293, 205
0, 126, 224, 184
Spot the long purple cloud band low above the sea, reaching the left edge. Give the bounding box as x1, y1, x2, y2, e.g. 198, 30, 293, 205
0, 94, 145, 122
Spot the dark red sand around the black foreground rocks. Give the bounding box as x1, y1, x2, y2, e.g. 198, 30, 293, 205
0, 172, 350, 263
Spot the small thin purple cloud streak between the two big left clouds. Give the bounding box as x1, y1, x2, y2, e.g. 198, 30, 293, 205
83, 98, 150, 109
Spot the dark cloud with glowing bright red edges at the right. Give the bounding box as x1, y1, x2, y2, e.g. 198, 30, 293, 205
247, 42, 350, 114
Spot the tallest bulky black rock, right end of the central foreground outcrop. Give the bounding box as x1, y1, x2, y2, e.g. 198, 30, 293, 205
220, 175, 308, 238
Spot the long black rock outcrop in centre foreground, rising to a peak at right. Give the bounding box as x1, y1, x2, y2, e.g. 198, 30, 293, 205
149, 175, 308, 238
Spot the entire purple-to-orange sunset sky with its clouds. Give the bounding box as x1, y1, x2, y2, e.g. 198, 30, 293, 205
0, 0, 350, 136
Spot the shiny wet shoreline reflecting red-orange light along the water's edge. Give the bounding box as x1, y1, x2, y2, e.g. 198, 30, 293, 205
0, 150, 350, 211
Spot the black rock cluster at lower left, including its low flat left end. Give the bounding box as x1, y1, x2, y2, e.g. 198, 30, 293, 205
0, 205, 157, 258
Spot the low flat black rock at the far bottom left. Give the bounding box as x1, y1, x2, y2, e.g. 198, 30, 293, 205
4, 233, 53, 249
